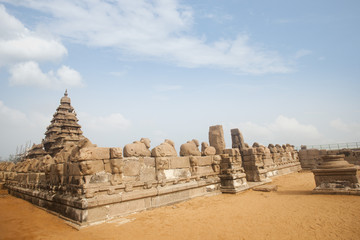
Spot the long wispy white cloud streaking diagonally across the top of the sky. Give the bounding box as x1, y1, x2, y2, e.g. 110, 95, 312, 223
4, 0, 291, 74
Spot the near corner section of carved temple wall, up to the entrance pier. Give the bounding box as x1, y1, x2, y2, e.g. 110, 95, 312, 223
0, 140, 221, 224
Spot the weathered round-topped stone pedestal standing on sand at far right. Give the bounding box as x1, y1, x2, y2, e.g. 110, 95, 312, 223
312, 154, 360, 195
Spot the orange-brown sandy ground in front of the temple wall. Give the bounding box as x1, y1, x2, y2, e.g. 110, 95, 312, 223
0, 172, 360, 240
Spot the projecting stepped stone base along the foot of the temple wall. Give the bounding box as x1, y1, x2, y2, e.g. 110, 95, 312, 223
8, 180, 221, 226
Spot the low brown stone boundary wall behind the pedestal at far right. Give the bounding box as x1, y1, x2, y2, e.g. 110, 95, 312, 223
299, 147, 360, 170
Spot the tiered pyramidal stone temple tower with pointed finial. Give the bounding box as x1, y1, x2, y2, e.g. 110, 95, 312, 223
43, 90, 84, 156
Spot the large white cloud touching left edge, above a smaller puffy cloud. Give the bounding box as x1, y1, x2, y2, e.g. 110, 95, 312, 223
0, 5, 67, 67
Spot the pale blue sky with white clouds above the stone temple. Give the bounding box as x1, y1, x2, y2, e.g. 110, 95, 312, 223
0, 0, 360, 159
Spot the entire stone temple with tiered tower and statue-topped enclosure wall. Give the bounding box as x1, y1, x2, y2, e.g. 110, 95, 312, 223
0, 92, 301, 225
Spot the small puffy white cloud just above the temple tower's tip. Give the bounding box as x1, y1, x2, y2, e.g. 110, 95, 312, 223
9, 61, 83, 89
